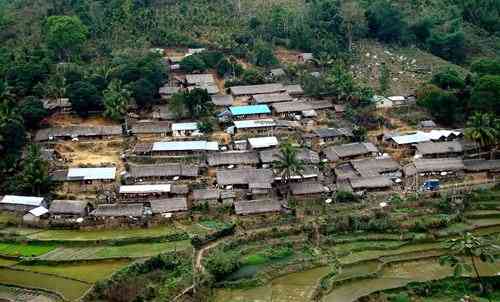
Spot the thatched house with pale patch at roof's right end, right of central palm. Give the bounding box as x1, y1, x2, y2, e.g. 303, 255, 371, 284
323, 143, 379, 162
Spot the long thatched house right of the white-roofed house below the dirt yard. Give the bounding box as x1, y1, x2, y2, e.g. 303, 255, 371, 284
124, 163, 199, 183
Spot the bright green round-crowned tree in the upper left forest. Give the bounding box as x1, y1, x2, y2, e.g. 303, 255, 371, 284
45, 16, 88, 59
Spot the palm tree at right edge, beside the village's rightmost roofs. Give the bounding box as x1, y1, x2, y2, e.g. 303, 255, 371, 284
464, 112, 500, 159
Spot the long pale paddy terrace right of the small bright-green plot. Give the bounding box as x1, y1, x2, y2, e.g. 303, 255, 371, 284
39, 240, 190, 261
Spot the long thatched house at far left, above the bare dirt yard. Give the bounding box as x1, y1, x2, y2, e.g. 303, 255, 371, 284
35, 126, 123, 142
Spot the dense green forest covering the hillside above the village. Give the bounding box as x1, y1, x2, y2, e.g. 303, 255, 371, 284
0, 0, 500, 194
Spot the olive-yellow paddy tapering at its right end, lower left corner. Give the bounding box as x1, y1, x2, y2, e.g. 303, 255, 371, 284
14, 260, 130, 283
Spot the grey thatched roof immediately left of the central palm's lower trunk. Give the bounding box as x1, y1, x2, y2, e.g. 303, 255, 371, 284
217, 168, 273, 186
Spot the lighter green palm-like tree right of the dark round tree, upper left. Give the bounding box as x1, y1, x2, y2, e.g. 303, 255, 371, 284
104, 79, 132, 121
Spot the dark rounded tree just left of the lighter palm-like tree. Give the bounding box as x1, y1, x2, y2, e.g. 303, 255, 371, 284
68, 81, 102, 116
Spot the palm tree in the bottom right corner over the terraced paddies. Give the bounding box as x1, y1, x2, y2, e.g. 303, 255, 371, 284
439, 233, 498, 301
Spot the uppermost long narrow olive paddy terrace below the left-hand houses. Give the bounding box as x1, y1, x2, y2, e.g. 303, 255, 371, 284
28, 226, 181, 241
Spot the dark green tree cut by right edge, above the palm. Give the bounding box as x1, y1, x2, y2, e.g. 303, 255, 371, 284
471, 75, 500, 115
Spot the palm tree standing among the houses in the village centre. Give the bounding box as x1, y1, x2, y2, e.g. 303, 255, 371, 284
274, 141, 304, 184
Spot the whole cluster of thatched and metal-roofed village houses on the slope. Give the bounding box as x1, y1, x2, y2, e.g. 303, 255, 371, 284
0, 50, 500, 221
